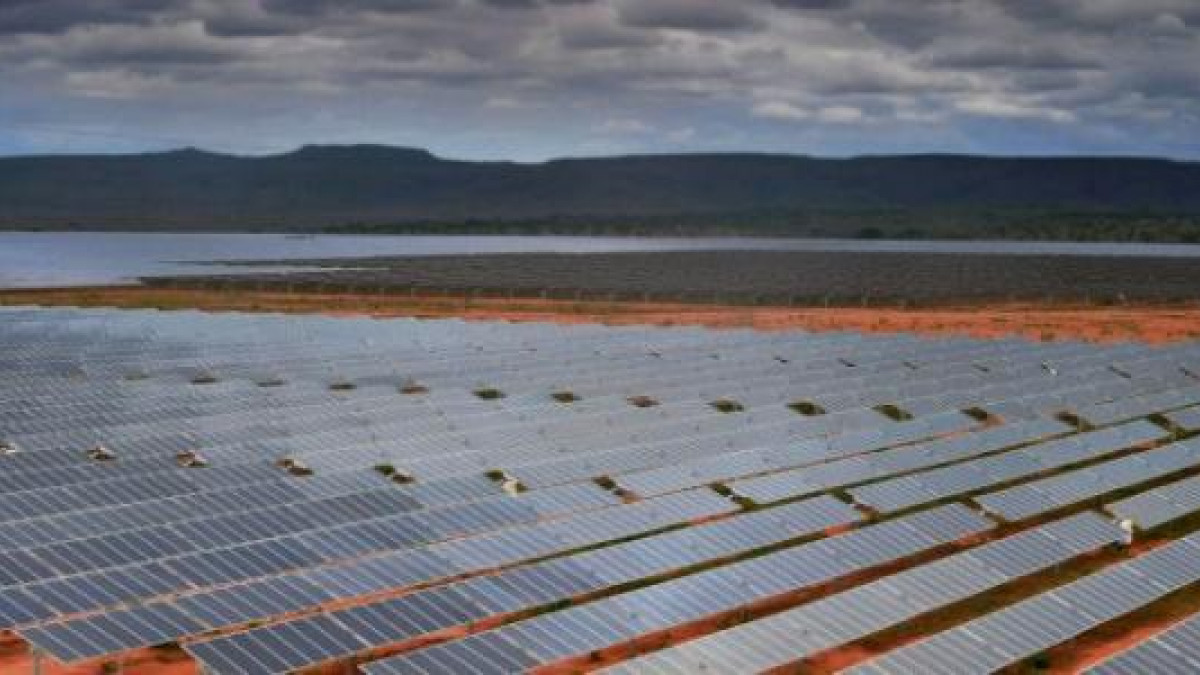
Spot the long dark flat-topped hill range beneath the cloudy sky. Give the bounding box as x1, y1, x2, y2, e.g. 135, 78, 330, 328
0, 145, 1200, 240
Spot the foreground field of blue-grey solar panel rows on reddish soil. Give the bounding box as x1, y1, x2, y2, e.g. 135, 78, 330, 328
0, 307, 1200, 675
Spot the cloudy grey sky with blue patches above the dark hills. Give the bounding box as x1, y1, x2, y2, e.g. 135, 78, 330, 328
0, 0, 1200, 161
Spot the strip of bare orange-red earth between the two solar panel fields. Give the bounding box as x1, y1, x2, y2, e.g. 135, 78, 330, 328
0, 286, 1200, 344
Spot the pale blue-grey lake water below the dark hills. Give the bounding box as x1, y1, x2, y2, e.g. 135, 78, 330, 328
0, 232, 1200, 288
